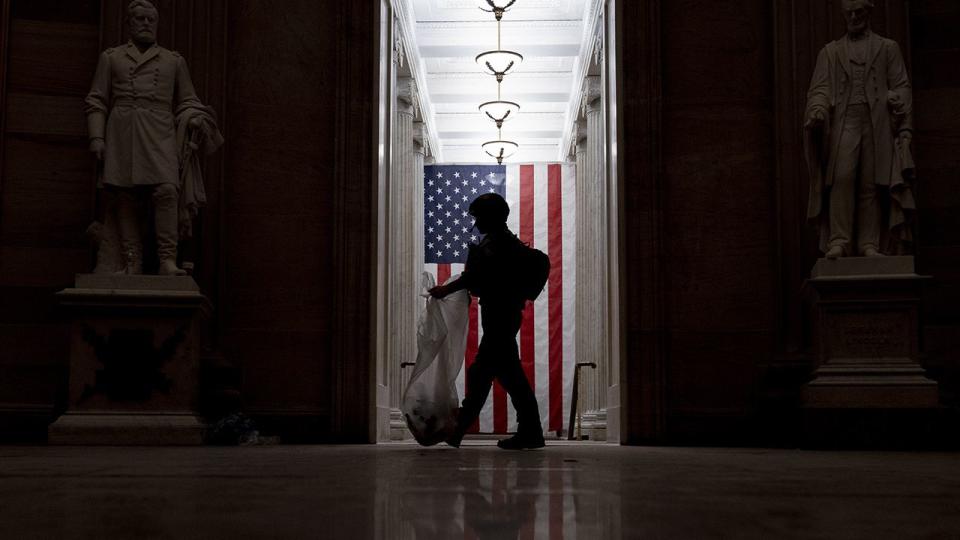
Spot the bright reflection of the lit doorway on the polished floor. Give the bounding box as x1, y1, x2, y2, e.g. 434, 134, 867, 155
377, 445, 620, 540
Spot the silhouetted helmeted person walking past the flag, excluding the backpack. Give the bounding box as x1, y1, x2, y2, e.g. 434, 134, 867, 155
430, 193, 544, 450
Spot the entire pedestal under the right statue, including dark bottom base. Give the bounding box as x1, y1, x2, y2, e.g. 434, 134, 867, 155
803, 257, 939, 446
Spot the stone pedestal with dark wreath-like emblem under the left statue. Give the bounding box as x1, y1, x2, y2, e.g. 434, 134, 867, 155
48, 274, 208, 445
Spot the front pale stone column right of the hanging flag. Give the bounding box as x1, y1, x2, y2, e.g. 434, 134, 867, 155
577, 76, 608, 439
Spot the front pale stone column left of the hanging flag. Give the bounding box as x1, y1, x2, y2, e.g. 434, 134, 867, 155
386, 77, 417, 438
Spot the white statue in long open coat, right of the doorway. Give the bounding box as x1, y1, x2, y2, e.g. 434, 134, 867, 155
804, 0, 916, 259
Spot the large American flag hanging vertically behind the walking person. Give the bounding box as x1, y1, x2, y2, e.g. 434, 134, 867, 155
423, 163, 576, 433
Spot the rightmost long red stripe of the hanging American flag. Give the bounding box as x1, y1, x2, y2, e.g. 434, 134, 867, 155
547, 164, 563, 431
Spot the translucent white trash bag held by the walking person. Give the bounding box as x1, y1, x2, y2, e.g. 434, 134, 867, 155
400, 272, 470, 446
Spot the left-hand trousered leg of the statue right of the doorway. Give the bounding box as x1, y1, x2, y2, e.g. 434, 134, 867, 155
827, 107, 861, 258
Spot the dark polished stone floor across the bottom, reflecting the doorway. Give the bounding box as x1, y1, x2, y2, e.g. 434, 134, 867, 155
0, 441, 960, 540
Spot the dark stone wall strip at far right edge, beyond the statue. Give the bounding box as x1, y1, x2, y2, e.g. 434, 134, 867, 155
910, 1, 960, 405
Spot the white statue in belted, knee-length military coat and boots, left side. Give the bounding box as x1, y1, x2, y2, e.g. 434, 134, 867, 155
86, 0, 223, 275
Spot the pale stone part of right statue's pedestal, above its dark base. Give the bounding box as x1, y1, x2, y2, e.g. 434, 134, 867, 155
803, 257, 938, 408
